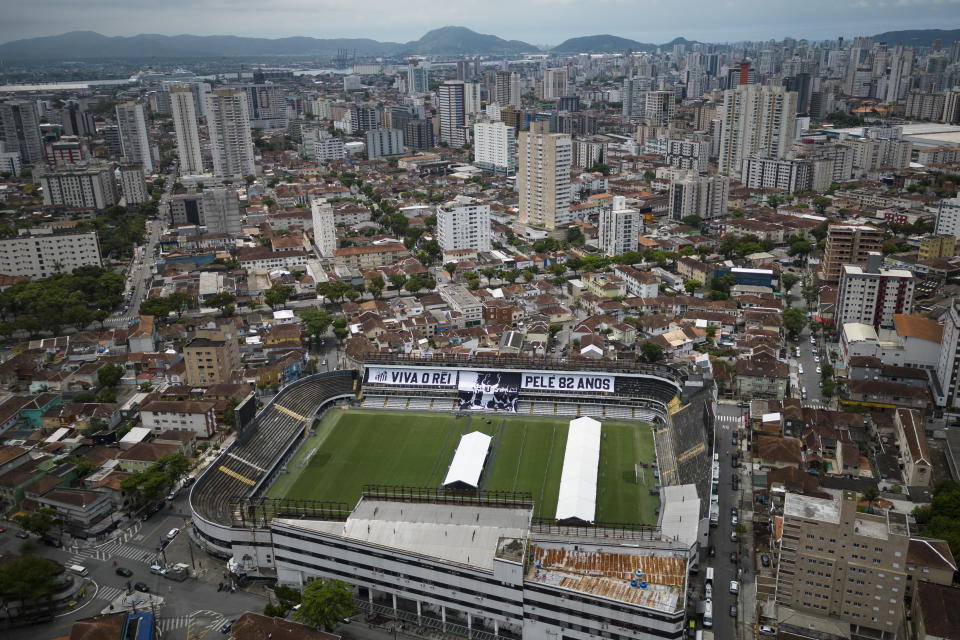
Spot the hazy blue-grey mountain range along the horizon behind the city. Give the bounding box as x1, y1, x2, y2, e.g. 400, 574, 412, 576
0, 27, 960, 60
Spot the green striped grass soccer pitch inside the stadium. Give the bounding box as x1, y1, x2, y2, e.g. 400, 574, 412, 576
268, 409, 659, 525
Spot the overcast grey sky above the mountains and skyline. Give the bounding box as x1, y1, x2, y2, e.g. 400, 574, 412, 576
0, 0, 960, 44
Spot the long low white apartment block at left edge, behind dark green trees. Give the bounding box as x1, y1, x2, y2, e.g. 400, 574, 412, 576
0, 227, 101, 280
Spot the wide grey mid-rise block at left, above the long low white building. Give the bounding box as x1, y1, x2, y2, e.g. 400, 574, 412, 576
35, 163, 118, 209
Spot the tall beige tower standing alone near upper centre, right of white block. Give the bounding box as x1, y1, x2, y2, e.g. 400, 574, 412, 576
517, 122, 572, 231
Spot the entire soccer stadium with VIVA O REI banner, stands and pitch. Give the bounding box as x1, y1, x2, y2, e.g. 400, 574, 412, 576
190, 354, 714, 640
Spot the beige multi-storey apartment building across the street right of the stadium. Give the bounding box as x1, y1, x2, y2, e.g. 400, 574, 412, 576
777, 491, 955, 638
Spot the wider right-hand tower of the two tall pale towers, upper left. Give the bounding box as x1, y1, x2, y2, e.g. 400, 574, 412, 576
207, 89, 257, 180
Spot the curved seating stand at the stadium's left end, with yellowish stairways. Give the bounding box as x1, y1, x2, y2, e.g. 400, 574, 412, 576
190, 371, 354, 524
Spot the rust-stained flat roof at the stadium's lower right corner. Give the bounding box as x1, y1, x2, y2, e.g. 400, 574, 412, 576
525, 542, 687, 613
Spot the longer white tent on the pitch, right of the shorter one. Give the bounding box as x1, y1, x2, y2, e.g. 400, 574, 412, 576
557, 417, 600, 522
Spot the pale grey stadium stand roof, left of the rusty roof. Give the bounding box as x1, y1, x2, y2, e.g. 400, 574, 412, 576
275, 499, 533, 571
